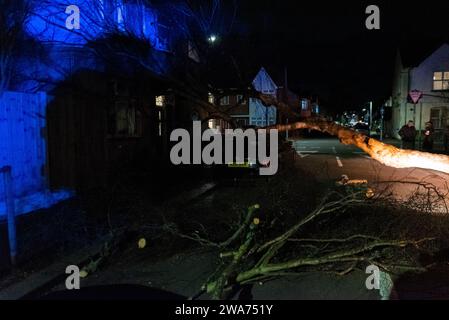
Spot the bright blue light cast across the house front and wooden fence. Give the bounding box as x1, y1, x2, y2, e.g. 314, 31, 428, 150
0, 0, 178, 219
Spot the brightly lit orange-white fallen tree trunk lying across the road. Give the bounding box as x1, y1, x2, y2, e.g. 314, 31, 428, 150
267, 120, 449, 174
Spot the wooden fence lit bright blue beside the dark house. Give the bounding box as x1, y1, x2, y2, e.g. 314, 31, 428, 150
0, 92, 71, 219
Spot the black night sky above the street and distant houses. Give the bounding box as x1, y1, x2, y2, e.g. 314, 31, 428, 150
224, 0, 449, 110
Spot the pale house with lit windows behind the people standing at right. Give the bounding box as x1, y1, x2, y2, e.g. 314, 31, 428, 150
387, 44, 449, 141
